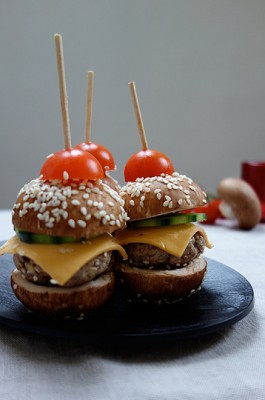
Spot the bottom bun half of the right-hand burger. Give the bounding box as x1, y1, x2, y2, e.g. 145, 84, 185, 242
116, 257, 207, 304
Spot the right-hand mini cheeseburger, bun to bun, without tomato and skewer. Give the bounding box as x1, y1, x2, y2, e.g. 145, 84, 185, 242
115, 172, 211, 304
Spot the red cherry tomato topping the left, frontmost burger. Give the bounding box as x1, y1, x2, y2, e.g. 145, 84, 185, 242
40, 148, 105, 181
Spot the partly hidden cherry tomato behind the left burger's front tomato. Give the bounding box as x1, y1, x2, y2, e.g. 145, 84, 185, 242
75, 142, 116, 170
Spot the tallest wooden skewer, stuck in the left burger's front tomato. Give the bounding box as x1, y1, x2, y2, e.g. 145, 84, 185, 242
54, 33, 71, 149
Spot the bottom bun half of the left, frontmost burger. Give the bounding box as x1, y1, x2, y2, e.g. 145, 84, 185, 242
11, 269, 115, 319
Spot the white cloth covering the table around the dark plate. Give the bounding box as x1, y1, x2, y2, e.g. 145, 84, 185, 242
0, 211, 265, 400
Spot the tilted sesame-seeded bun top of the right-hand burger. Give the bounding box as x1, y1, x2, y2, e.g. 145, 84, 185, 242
119, 172, 207, 220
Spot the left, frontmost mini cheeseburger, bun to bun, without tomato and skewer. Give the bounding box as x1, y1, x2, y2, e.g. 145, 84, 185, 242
0, 179, 127, 319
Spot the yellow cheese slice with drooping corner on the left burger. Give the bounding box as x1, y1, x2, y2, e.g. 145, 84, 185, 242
0, 234, 127, 285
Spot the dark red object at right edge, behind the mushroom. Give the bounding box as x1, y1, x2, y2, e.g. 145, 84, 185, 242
241, 161, 265, 221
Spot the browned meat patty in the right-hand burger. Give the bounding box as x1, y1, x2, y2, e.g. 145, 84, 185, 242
124, 232, 205, 269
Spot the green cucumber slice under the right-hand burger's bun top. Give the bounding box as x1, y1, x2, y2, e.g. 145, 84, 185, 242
128, 213, 207, 228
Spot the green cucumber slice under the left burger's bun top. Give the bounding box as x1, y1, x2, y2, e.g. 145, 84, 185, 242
15, 228, 79, 244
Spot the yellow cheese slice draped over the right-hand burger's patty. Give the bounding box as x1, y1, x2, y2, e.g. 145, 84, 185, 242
115, 224, 212, 257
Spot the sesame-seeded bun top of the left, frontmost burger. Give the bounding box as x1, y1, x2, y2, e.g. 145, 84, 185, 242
12, 179, 128, 239
